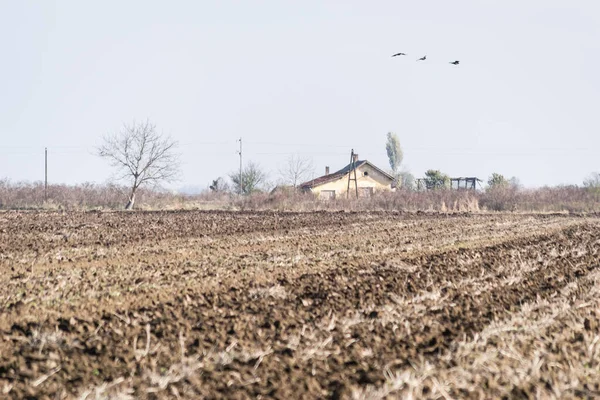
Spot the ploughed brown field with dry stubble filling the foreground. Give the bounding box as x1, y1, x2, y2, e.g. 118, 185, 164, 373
0, 212, 600, 400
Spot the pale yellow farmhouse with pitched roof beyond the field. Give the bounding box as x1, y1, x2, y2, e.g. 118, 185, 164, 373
300, 154, 394, 199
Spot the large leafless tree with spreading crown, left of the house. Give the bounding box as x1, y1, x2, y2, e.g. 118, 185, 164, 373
97, 120, 180, 210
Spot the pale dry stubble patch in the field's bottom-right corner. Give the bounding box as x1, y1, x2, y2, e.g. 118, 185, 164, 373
352, 260, 600, 400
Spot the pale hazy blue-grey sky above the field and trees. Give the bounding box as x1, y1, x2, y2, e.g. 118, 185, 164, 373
0, 0, 600, 189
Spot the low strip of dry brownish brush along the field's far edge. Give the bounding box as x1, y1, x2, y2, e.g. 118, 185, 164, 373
0, 179, 600, 212
